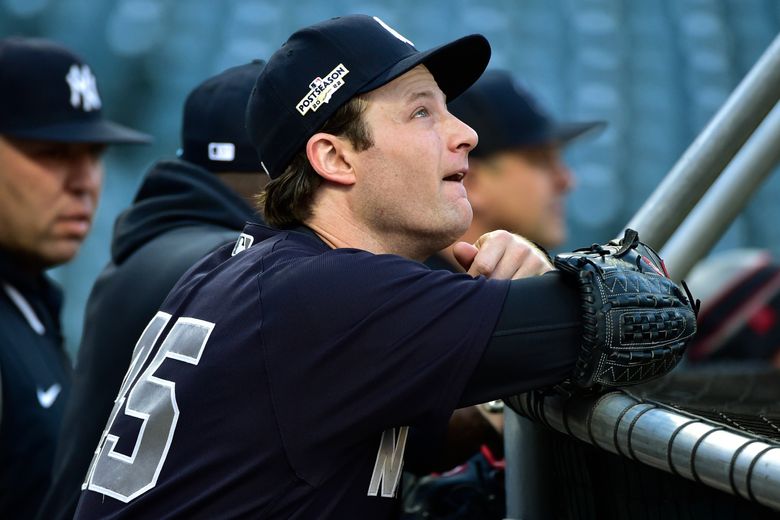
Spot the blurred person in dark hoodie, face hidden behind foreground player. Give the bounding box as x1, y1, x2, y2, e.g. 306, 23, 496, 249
39, 60, 268, 520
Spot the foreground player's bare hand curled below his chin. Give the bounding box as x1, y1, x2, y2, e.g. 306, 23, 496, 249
452, 230, 555, 280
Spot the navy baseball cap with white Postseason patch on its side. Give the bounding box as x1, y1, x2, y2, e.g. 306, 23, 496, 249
246, 15, 490, 178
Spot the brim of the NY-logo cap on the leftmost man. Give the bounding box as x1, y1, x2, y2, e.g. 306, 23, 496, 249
0, 120, 152, 144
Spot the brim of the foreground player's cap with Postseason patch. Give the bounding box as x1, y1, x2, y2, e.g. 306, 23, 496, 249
359, 34, 490, 102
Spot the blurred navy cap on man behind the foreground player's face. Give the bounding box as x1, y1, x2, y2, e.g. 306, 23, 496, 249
448, 69, 606, 157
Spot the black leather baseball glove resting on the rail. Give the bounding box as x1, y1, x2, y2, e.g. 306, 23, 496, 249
554, 229, 698, 392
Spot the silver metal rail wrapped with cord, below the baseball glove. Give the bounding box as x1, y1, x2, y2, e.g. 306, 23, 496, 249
507, 391, 780, 510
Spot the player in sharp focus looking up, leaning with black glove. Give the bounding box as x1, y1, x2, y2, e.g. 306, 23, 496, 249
71, 15, 695, 519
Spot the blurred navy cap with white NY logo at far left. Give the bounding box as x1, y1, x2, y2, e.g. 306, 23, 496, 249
0, 37, 151, 144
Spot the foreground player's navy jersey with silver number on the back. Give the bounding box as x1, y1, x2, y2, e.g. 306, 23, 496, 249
76, 225, 509, 519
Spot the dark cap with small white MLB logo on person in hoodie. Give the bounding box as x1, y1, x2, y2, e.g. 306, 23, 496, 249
180, 60, 265, 172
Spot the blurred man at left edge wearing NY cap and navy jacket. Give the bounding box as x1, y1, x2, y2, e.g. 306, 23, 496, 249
0, 37, 149, 519
